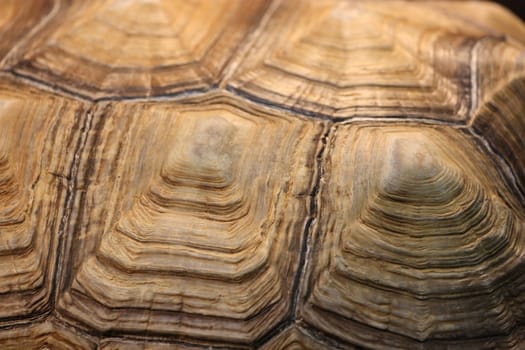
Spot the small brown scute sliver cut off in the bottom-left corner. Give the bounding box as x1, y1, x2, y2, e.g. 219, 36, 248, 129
0, 321, 97, 350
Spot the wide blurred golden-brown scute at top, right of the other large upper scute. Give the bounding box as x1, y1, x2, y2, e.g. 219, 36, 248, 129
229, 0, 486, 121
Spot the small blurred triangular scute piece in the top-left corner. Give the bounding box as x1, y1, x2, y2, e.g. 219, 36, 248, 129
0, 0, 56, 64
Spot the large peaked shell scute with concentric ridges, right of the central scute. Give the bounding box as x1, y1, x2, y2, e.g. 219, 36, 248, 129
300, 123, 525, 349
